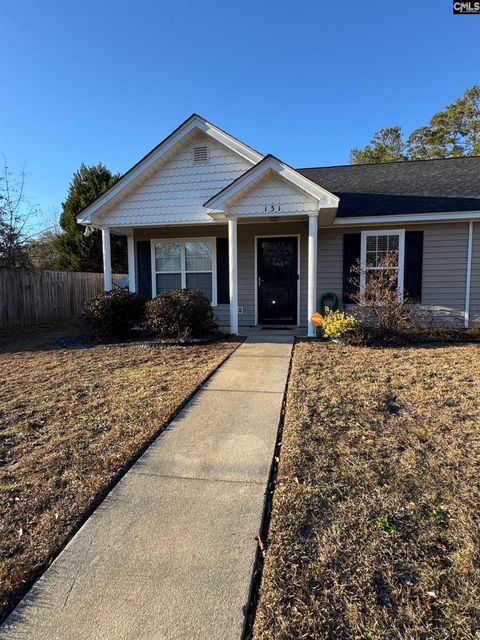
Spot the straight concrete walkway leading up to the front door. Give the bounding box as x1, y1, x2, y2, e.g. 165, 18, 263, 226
0, 332, 292, 640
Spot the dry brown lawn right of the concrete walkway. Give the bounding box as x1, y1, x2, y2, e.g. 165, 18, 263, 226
254, 342, 480, 640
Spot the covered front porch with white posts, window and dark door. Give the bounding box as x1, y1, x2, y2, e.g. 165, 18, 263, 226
102, 216, 318, 335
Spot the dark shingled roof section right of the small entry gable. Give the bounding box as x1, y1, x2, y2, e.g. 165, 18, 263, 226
297, 156, 480, 218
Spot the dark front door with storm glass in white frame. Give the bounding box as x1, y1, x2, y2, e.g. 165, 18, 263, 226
257, 238, 298, 324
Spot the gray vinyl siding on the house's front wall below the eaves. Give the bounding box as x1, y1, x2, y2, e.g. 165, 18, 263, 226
135, 220, 480, 327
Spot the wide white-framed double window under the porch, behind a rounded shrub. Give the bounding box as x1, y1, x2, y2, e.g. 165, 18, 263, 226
152, 238, 217, 305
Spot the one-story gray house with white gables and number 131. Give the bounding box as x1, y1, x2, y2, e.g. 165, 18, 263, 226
78, 114, 480, 335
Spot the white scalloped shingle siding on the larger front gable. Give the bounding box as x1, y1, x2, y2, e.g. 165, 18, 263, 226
102, 133, 252, 227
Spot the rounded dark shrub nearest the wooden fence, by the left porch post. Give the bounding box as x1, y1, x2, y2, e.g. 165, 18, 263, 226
81, 289, 145, 341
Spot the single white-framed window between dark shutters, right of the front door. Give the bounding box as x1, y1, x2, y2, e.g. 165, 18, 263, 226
360, 229, 405, 297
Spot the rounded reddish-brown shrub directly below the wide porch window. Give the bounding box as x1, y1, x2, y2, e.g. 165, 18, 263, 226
145, 289, 218, 340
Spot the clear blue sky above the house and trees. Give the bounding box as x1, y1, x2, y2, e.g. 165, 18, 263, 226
0, 0, 480, 230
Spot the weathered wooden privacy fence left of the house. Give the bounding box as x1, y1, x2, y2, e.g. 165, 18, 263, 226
0, 269, 124, 328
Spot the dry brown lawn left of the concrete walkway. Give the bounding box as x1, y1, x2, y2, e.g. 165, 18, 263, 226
0, 330, 238, 618
